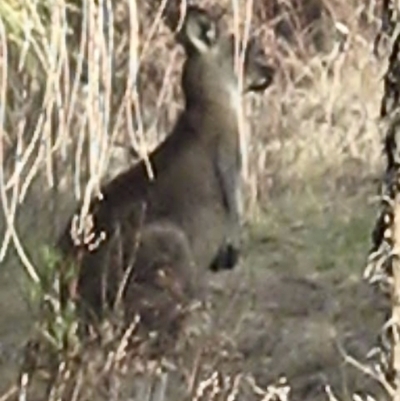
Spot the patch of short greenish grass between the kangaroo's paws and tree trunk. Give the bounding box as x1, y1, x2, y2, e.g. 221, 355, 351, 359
246, 179, 376, 274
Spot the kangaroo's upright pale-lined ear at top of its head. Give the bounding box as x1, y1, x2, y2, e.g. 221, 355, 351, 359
177, 6, 219, 53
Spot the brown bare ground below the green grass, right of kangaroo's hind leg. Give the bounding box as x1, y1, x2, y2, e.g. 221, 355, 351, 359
205, 263, 386, 400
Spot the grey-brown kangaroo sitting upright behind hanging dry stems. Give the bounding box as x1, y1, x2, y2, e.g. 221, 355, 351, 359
58, 7, 274, 324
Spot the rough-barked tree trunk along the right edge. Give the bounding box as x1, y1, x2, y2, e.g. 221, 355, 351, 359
366, 1, 400, 400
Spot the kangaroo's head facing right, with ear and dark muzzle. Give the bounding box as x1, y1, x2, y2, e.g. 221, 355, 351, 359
178, 7, 274, 107
